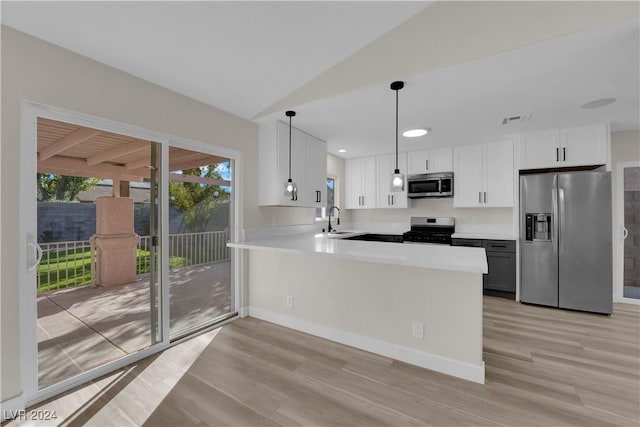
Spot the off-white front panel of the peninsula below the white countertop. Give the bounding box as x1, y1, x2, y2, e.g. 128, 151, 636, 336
249, 250, 484, 381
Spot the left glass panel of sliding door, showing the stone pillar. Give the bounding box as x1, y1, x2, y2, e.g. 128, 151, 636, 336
31, 118, 162, 390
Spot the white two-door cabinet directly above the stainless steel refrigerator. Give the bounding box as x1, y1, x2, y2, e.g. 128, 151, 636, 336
520, 124, 609, 169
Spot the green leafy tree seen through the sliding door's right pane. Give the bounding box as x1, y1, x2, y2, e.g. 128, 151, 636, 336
169, 164, 230, 232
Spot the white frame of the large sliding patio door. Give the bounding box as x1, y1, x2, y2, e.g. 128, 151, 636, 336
18, 100, 242, 406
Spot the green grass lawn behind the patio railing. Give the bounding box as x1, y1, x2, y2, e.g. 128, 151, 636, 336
38, 247, 188, 292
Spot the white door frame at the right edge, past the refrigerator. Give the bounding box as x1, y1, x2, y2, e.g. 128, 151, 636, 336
613, 161, 640, 305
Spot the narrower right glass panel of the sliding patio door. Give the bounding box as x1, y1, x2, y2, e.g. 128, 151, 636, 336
168, 147, 235, 339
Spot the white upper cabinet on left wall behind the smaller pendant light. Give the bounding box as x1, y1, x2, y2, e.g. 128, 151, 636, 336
258, 121, 327, 207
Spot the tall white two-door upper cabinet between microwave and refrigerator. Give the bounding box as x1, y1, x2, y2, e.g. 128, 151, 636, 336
453, 140, 515, 208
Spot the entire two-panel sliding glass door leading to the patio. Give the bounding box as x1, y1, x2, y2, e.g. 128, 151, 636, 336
18, 101, 239, 405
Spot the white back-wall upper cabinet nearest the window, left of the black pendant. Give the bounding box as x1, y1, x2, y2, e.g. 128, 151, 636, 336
345, 157, 377, 209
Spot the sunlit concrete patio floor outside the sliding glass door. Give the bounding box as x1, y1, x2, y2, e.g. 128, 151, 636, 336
38, 260, 231, 387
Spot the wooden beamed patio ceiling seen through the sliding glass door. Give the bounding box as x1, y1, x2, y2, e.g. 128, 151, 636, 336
37, 118, 231, 185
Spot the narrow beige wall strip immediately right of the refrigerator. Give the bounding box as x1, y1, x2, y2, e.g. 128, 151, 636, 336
611, 130, 640, 301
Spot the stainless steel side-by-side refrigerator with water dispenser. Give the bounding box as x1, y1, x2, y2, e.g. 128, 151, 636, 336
520, 172, 613, 314
